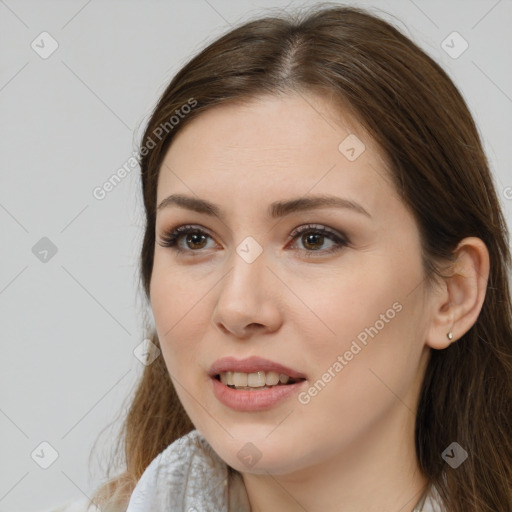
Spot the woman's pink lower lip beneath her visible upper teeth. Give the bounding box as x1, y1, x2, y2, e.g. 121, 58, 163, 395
212, 378, 306, 412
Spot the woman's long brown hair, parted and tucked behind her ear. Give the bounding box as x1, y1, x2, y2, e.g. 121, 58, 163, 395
91, 4, 512, 512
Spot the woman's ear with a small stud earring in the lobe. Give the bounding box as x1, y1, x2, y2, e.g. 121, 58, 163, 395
426, 237, 489, 350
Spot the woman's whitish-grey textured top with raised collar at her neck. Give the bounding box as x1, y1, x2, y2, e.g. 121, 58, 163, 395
47, 430, 444, 512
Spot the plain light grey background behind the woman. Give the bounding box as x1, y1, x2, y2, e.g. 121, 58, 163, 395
0, 0, 512, 512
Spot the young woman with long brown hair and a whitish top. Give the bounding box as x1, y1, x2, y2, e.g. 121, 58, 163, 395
54, 7, 512, 512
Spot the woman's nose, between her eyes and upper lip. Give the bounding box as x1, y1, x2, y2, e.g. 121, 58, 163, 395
212, 247, 282, 339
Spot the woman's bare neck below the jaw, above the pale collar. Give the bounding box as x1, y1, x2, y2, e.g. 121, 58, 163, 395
242, 403, 427, 512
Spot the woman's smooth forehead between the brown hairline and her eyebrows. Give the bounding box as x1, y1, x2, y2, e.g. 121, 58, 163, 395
157, 93, 393, 212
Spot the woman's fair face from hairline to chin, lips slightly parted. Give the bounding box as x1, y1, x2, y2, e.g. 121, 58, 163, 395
150, 94, 430, 474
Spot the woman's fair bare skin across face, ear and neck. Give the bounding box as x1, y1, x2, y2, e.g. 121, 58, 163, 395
150, 93, 488, 512
